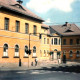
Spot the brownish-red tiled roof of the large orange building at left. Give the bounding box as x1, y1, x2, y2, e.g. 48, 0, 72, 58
0, 0, 43, 21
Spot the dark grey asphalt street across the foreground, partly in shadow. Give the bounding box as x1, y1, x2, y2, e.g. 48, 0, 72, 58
0, 65, 80, 80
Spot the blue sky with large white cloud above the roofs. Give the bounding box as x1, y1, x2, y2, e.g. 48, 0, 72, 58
22, 0, 80, 26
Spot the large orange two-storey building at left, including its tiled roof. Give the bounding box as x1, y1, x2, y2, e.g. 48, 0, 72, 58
0, 0, 43, 67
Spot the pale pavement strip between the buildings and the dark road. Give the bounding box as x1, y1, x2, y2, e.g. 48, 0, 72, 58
0, 61, 80, 71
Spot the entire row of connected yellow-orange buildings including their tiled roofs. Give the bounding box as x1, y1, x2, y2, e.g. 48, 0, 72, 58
0, 0, 80, 67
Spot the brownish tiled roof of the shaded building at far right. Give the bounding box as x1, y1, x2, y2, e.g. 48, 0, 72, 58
50, 24, 80, 36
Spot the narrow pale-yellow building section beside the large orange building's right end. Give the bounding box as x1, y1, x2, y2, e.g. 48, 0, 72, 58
40, 24, 50, 60
